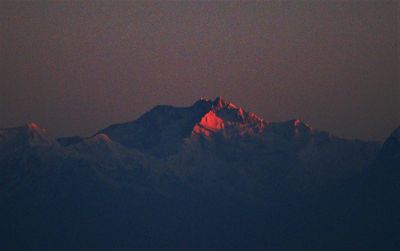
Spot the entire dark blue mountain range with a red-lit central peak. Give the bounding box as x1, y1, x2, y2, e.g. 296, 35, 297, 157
0, 97, 400, 250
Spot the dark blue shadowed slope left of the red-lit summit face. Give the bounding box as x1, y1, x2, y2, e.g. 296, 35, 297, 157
97, 97, 212, 156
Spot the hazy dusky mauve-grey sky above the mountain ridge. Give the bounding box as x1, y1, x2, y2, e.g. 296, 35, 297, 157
0, 0, 400, 140
